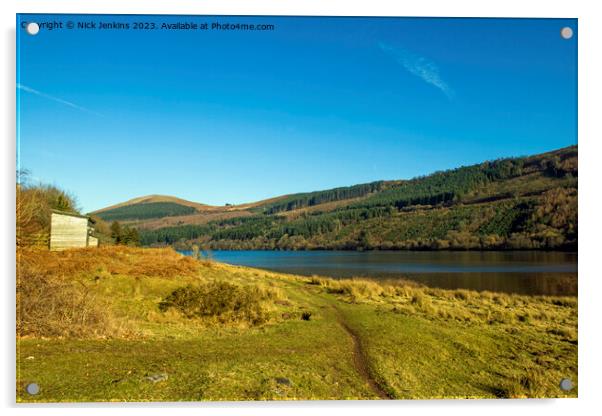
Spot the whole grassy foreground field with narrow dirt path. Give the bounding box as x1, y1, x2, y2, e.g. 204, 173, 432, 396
17, 247, 578, 402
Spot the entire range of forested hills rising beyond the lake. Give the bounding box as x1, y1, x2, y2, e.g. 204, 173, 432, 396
95, 146, 578, 249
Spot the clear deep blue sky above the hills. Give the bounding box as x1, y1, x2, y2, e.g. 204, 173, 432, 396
17, 15, 577, 212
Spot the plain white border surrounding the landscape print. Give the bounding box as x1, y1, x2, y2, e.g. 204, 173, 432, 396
0, 0, 602, 416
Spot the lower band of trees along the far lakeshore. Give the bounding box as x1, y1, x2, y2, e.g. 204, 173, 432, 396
141, 188, 577, 249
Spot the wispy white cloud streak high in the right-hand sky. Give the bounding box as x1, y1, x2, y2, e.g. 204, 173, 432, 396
378, 42, 454, 99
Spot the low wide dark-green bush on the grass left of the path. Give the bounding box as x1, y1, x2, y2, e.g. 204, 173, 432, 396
159, 281, 276, 325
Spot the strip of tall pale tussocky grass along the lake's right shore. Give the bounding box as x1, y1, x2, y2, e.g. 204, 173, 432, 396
307, 276, 577, 334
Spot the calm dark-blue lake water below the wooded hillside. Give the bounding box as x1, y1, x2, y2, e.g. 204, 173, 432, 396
182, 251, 577, 295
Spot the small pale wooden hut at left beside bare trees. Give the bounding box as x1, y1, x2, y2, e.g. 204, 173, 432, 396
50, 210, 98, 250
